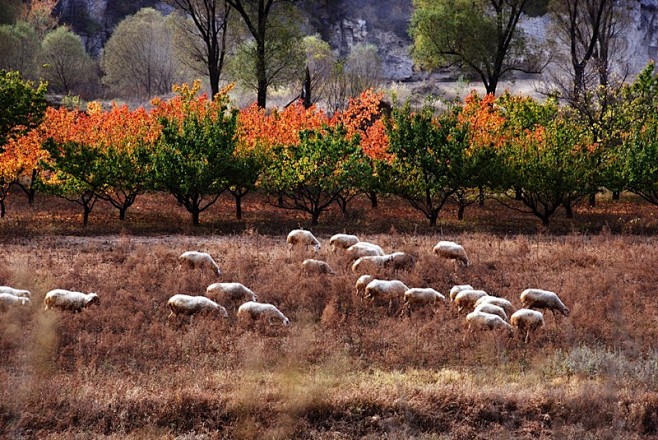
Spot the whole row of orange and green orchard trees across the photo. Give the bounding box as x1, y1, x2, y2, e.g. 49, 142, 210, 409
0, 65, 658, 226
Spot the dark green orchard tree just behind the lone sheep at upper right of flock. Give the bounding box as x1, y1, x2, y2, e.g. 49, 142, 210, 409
379, 104, 468, 226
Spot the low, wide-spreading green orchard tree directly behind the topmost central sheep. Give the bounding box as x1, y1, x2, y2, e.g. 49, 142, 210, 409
262, 125, 371, 225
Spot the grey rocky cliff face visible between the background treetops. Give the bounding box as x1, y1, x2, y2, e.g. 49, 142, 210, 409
56, 0, 658, 81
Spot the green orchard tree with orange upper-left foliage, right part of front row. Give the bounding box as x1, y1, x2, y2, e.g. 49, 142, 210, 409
498, 95, 598, 226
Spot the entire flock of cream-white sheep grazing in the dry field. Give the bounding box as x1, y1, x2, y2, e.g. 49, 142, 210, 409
0, 229, 570, 343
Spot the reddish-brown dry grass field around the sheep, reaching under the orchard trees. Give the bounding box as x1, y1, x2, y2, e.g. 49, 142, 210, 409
0, 196, 658, 439
